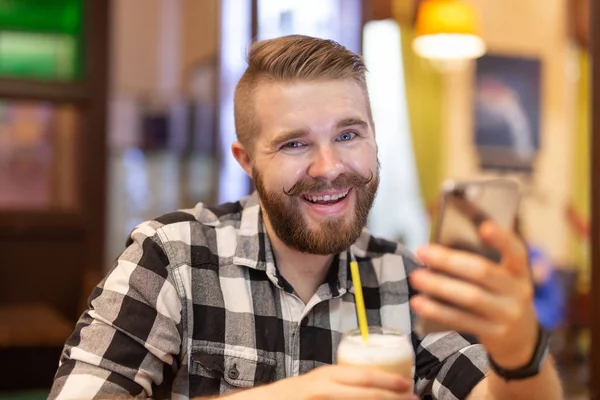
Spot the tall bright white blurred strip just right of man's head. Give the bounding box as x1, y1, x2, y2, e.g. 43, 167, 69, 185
363, 20, 429, 251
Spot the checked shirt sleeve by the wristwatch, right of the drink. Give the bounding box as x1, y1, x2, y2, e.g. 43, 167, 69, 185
415, 332, 488, 400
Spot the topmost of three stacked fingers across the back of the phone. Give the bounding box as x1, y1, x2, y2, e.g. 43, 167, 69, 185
417, 245, 512, 292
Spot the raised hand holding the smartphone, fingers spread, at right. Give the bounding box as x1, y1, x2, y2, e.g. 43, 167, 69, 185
410, 221, 538, 369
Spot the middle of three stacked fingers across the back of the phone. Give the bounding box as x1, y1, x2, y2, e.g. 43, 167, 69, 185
410, 269, 512, 321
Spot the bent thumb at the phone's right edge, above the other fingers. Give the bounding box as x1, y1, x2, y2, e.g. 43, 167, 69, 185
479, 221, 530, 277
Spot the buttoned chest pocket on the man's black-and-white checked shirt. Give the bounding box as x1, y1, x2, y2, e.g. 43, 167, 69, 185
190, 346, 275, 395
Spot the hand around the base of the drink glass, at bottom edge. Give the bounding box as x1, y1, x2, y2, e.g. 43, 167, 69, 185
229, 365, 417, 400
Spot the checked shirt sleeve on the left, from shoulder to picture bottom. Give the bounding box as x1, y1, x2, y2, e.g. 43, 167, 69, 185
49, 222, 182, 399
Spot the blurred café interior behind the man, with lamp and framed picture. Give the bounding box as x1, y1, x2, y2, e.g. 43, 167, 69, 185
0, 0, 600, 399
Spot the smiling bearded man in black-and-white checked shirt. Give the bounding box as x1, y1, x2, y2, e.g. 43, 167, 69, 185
51, 36, 560, 400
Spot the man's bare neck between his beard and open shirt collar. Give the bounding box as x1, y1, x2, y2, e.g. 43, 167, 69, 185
263, 214, 334, 304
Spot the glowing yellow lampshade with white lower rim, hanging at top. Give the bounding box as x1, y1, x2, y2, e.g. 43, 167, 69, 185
413, 0, 485, 61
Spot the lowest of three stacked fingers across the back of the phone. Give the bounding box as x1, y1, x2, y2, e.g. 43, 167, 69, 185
410, 295, 502, 336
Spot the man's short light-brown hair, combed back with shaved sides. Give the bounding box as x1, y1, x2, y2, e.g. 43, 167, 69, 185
233, 35, 373, 153
